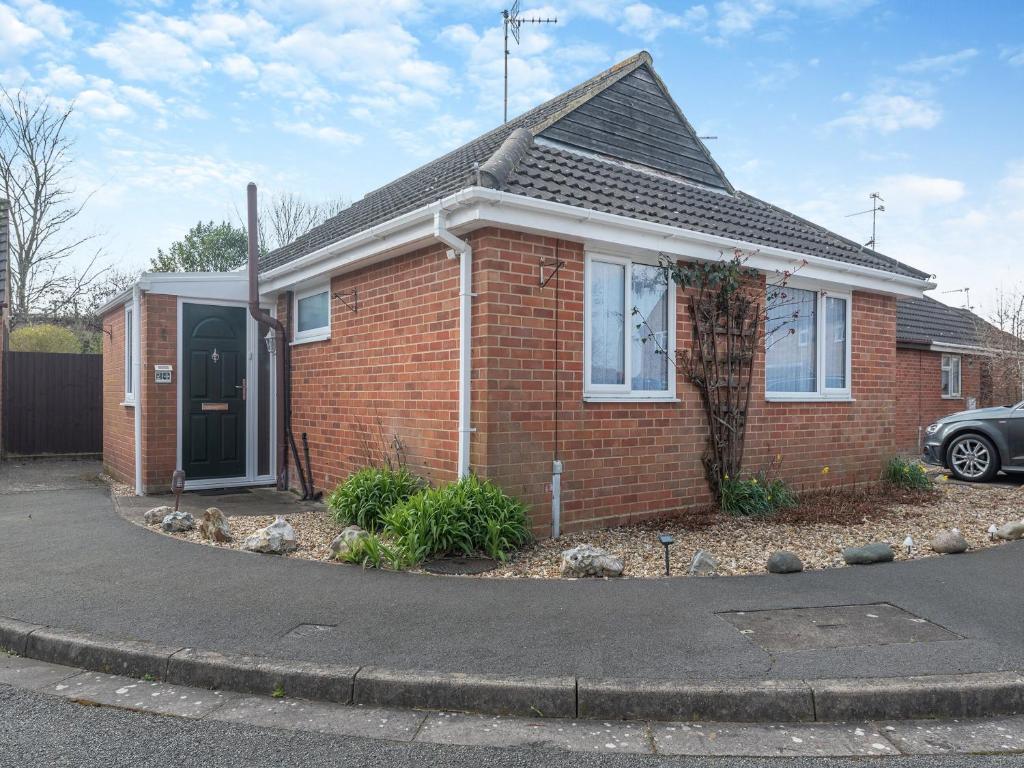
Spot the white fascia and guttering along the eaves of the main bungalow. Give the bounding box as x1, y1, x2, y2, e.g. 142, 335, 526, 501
260, 186, 935, 297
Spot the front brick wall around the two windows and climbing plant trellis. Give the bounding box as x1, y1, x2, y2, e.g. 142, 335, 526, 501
473, 229, 896, 534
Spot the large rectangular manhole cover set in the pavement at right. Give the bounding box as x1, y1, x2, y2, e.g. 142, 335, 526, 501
718, 603, 961, 651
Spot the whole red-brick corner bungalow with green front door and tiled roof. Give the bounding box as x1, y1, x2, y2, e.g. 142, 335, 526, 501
103, 52, 932, 534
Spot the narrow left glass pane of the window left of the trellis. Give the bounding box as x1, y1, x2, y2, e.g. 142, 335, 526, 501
590, 261, 626, 384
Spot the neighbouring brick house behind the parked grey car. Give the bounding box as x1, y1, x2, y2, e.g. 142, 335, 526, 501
896, 296, 1024, 453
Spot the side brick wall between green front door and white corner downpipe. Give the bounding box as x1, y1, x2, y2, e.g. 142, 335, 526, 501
288, 240, 464, 489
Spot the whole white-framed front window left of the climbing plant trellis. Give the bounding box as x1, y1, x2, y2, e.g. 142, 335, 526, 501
584, 254, 676, 401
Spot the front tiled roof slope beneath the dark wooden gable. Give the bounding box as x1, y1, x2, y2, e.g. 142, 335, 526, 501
507, 144, 928, 279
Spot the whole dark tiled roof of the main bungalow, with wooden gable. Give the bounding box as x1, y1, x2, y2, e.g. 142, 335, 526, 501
260, 51, 929, 280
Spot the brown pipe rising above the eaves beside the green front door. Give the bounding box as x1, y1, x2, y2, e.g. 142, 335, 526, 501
246, 181, 312, 500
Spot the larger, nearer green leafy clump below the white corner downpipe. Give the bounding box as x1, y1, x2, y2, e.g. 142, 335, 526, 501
383, 475, 530, 566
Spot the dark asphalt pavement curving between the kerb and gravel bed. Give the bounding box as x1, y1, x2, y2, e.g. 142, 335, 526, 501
0, 464, 1024, 679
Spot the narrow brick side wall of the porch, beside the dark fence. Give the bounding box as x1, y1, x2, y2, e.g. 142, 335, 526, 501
101, 304, 135, 484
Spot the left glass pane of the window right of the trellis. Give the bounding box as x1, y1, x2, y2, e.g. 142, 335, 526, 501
765, 288, 818, 392
